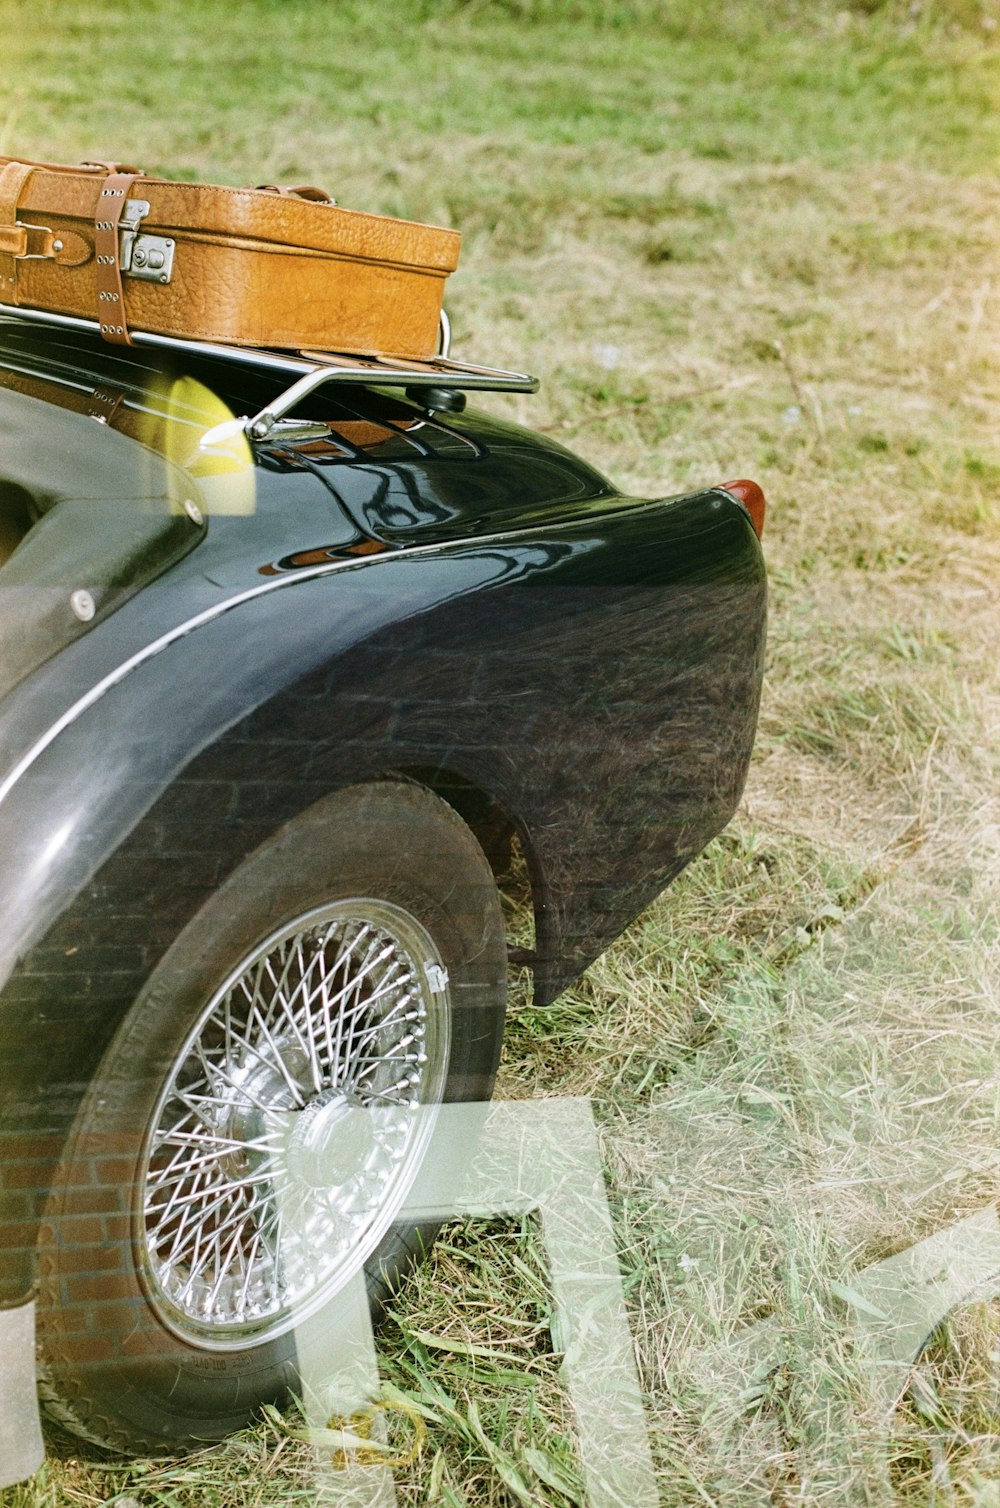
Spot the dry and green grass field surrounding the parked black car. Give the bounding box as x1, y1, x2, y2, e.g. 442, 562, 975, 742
0, 0, 1000, 1508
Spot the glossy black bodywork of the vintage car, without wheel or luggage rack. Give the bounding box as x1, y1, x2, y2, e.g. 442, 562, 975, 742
0, 320, 765, 1294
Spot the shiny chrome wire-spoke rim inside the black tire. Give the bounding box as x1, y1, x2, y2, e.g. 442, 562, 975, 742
140, 900, 448, 1348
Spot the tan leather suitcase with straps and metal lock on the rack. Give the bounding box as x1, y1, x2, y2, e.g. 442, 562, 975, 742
0, 157, 460, 357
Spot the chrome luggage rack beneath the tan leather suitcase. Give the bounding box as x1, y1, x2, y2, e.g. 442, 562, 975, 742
0, 305, 538, 442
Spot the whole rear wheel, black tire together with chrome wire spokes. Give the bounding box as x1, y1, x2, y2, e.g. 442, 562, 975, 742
38, 780, 507, 1452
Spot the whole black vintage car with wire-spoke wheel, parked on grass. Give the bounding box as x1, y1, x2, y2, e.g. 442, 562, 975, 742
0, 311, 765, 1451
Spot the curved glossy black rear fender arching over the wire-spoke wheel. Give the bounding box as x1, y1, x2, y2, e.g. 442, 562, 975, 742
0, 493, 765, 1296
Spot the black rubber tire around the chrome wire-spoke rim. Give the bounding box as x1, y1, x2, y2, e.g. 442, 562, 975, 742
38, 781, 507, 1454
